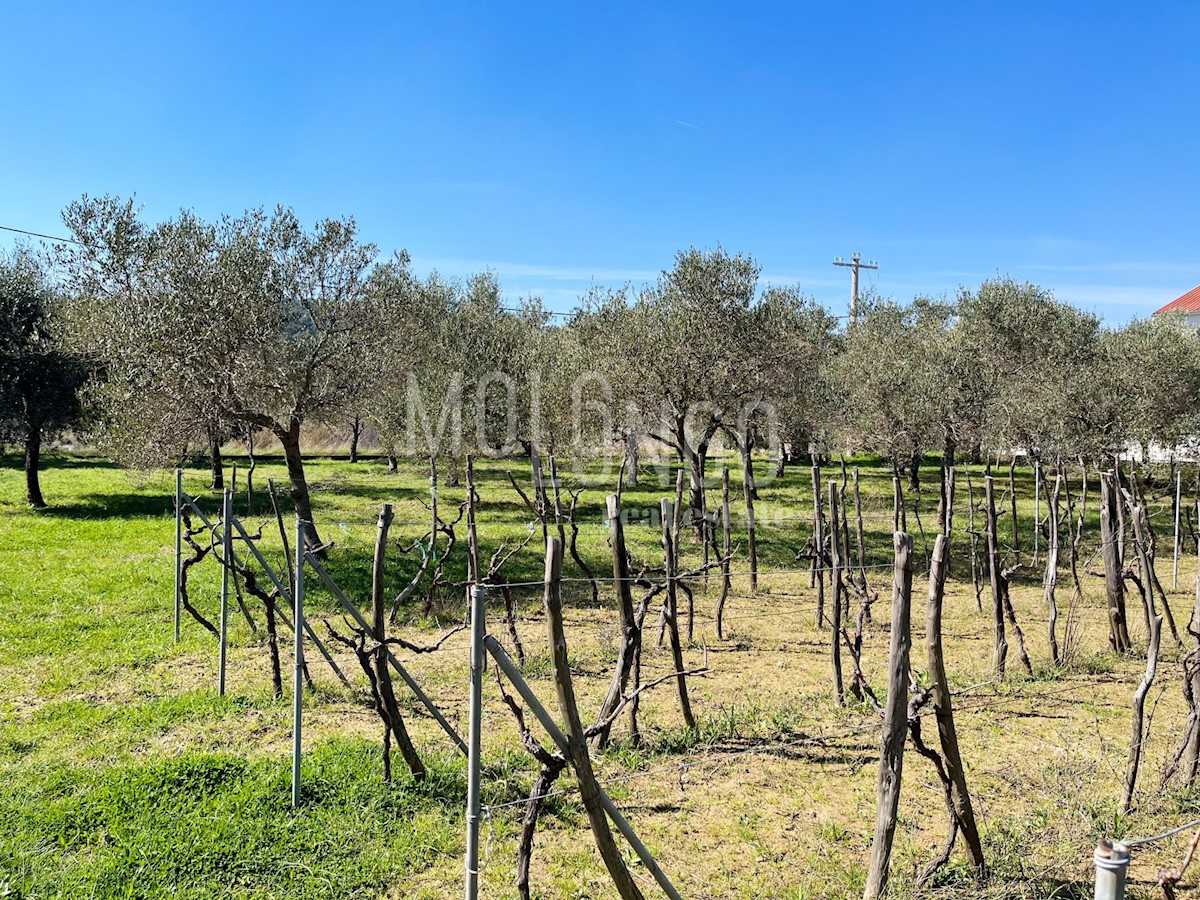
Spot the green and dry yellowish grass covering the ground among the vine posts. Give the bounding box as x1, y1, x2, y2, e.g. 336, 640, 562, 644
0, 454, 1200, 899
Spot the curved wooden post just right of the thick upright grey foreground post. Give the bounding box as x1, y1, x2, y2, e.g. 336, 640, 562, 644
925, 535, 984, 871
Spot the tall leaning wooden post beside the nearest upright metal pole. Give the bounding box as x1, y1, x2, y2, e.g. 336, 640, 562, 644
542, 540, 648, 900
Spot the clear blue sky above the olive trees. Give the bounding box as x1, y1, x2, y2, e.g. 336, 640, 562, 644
0, 1, 1200, 322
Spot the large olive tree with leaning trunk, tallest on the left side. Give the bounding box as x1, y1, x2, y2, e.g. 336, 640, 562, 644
62, 196, 377, 546
